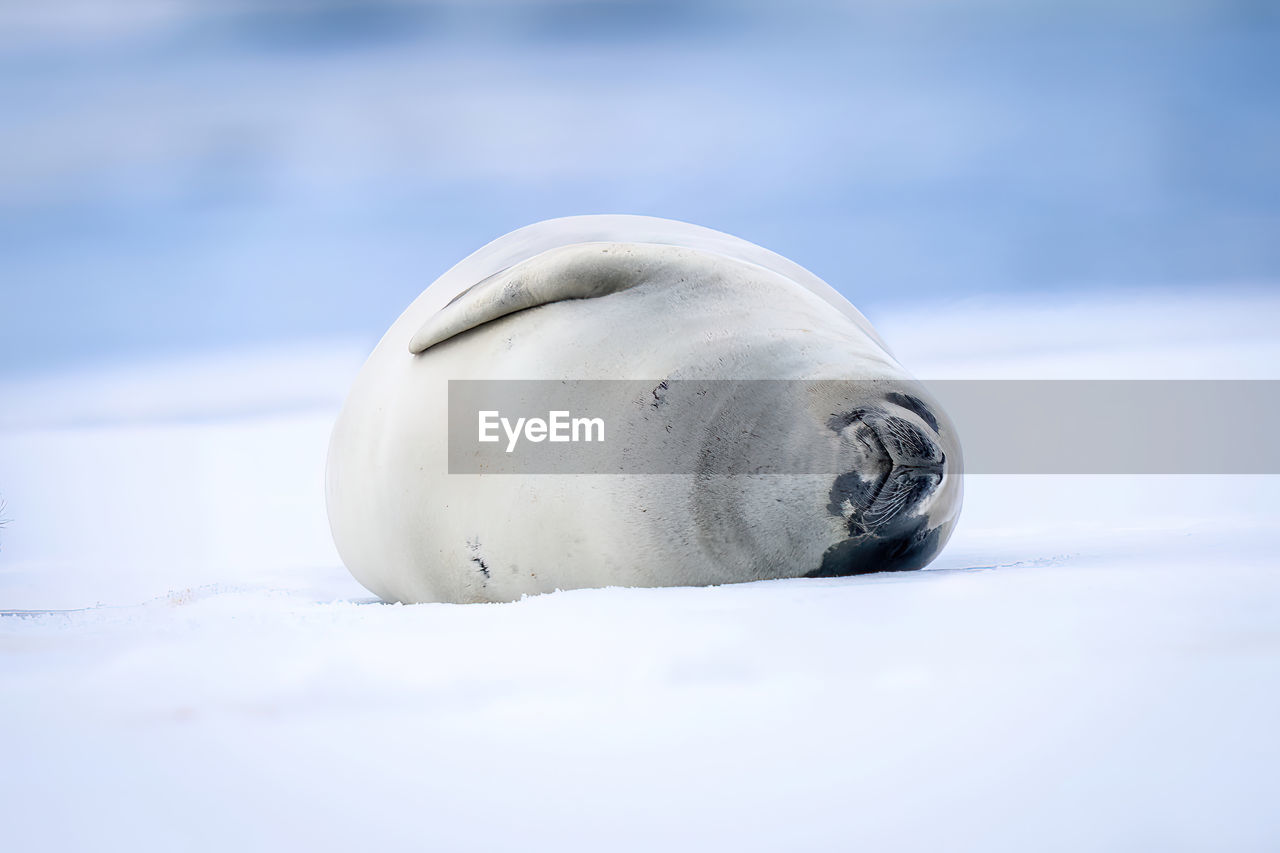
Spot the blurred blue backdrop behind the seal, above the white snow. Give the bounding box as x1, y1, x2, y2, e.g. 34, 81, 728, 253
0, 0, 1280, 378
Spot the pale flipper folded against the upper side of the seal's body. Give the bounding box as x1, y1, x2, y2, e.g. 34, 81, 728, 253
408, 243, 685, 355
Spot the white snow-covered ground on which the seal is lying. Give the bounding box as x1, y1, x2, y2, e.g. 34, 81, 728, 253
0, 289, 1280, 850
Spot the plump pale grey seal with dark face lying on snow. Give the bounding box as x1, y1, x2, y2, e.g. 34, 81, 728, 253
326, 215, 961, 603
